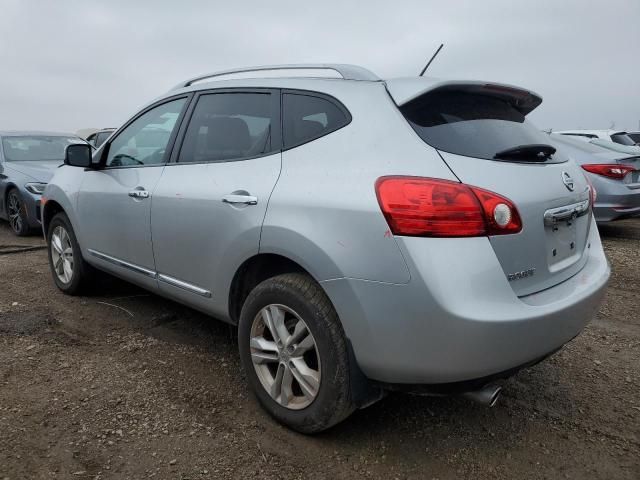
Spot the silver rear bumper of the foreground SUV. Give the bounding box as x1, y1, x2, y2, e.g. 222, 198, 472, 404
322, 219, 610, 384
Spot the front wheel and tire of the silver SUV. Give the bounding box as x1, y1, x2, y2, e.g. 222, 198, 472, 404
47, 213, 94, 295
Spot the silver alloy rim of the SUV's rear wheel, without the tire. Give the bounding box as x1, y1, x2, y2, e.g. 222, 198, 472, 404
250, 304, 321, 410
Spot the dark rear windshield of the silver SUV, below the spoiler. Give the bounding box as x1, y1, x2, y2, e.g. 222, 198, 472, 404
400, 91, 564, 161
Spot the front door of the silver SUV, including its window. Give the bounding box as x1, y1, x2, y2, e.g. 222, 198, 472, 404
78, 97, 187, 287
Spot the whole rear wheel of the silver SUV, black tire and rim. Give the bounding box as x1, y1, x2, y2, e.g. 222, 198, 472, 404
238, 273, 354, 433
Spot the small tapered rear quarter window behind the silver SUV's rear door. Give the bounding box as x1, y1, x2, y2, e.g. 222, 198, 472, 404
282, 93, 351, 148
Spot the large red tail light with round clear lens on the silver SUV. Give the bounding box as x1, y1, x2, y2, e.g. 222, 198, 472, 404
376, 177, 522, 237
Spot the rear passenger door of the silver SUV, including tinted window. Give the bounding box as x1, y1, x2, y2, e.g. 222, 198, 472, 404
151, 89, 281, 316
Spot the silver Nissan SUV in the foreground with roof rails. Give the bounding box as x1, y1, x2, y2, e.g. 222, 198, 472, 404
43, 65, 609, 433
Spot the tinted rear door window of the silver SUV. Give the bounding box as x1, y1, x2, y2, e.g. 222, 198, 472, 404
178, 92, 276, 163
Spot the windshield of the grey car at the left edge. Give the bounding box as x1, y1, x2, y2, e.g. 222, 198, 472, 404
2, 135, 83, 162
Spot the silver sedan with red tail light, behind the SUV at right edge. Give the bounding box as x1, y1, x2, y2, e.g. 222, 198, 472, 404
550, 134, 640, 223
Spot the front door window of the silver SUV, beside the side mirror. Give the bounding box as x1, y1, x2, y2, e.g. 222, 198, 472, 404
106, 98, 187, 167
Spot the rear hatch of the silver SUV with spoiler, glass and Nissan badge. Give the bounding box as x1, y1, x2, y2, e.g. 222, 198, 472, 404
387, 79, 591, 296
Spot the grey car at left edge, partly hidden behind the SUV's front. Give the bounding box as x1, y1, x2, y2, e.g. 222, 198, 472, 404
0, 131, 84, 236
